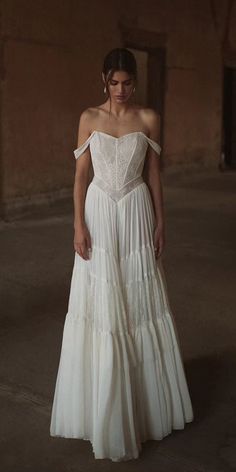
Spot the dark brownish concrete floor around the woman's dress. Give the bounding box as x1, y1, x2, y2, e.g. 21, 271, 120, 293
0, 169, 236, 472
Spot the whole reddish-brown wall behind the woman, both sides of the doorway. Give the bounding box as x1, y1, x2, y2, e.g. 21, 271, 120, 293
0, 0, 236, 218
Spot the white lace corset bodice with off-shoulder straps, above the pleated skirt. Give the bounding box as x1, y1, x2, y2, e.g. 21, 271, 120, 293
74, 131, 161, 201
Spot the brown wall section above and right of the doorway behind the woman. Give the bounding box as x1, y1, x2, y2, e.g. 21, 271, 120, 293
120, 0, 236, 167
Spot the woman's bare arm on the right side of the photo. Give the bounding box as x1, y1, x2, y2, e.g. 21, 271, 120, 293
143, 109, 165, 257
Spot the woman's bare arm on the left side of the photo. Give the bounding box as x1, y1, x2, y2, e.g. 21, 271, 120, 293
73, 110, 91, 259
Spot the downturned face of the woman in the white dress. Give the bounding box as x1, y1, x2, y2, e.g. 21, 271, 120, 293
105, 70, 135, 103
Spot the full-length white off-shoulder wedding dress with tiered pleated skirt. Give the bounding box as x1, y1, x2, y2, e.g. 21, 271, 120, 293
50, 131, 193, 461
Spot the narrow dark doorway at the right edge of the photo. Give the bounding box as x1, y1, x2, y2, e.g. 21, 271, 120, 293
223, 67, 236, 169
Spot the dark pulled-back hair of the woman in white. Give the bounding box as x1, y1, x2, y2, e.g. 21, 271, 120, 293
102, 48, 137, 112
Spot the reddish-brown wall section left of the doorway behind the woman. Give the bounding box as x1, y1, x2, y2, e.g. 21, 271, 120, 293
1, 0, 121, 216
